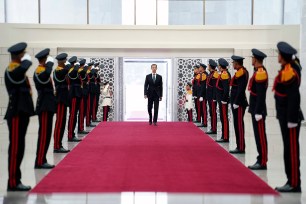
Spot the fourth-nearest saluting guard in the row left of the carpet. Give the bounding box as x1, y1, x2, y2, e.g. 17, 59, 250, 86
67, 56, 82, 142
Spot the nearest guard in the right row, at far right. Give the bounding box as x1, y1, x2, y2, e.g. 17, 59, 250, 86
273, 42, 304, 192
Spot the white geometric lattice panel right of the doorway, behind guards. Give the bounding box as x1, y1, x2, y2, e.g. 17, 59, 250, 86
177, 58, 233, 129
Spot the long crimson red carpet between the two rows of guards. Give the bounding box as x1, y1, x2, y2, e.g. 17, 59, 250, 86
31, 122, 277, 195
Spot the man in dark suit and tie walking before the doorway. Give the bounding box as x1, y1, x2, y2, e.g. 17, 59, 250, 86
144, 64, 163, 126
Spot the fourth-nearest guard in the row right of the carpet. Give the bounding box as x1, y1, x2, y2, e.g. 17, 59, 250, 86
216, 58, 231, 142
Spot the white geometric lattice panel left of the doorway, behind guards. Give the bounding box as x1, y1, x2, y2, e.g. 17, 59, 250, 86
90, 58, 115, 121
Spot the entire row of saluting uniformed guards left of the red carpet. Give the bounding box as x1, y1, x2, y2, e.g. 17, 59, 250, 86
5, 42, 106, 191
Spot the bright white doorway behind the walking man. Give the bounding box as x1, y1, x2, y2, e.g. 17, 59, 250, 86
123, 58, 172, 121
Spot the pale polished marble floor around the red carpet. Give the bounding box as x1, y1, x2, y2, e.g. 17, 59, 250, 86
0, 114, 306, 204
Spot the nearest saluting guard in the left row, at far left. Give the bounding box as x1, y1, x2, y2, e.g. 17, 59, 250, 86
4, 42, 34, 191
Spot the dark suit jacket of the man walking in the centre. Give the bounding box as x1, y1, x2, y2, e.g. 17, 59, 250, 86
144, 73, 163, 98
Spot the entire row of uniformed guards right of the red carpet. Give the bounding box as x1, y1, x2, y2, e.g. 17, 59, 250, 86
189, 42, 304, 192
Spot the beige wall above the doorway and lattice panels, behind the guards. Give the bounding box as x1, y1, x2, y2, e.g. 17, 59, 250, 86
0, 24, 300, 116
